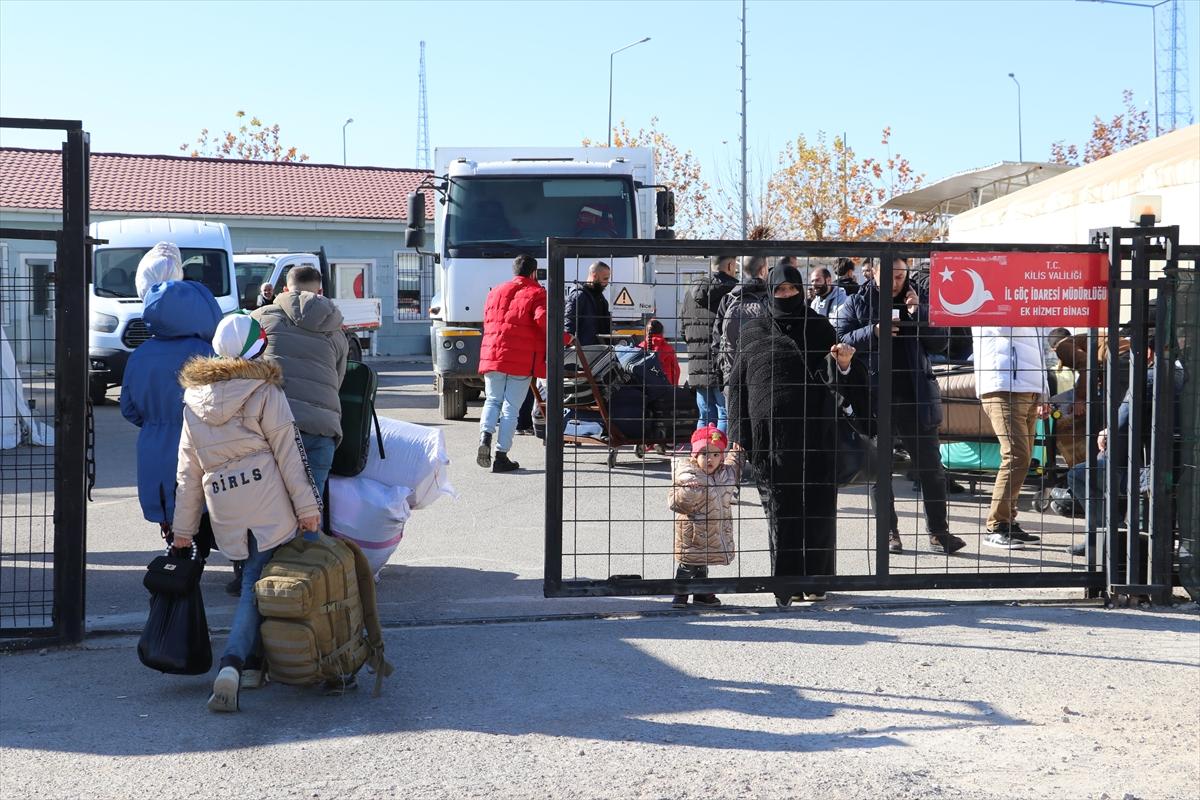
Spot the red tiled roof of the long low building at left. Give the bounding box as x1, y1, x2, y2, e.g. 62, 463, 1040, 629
0, 148, 433, 222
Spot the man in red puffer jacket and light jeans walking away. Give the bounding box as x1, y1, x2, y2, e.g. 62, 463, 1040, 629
475, 255, 546, 473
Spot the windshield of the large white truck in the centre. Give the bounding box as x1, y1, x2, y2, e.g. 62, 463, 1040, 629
446, 175, 635, 252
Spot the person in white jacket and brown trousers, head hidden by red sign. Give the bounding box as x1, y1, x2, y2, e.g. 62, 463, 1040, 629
971, 327, 1049, 551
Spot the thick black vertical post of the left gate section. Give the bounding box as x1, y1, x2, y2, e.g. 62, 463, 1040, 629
54, 128, 89, 644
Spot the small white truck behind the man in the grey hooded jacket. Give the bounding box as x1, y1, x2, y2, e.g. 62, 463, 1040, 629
233, 248, 383, 361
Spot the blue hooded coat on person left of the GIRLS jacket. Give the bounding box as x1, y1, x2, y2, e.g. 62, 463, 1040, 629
121, 281, 221, 536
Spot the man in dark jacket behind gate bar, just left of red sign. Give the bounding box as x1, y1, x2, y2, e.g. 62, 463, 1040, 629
836, 258, 966, 553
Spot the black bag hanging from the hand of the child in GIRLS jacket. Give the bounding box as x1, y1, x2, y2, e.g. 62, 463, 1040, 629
138, 546, 212, 675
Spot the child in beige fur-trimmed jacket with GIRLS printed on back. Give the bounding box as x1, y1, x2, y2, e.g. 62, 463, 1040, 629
174, 314, 322, 711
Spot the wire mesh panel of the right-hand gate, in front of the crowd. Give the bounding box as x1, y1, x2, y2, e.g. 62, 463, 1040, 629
539, 237, 1190, 599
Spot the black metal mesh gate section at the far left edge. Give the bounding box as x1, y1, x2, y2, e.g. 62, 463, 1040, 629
0, 118, 89, 643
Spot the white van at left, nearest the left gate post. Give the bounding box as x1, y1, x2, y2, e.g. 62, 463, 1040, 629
88, 218, 238, 404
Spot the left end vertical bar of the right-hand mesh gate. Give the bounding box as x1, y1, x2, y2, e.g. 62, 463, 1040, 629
542, 239, 566, 597
